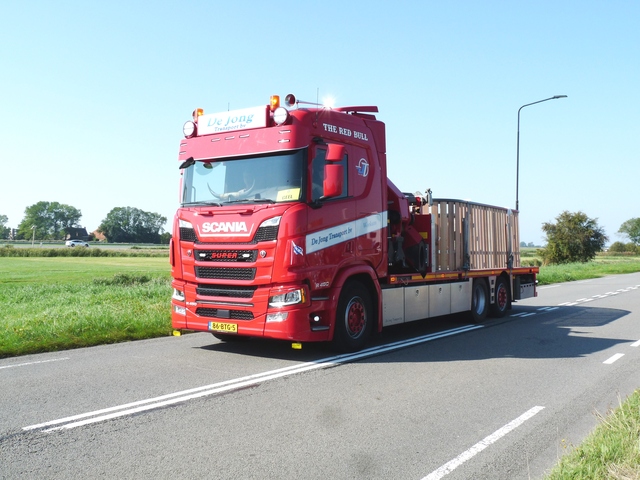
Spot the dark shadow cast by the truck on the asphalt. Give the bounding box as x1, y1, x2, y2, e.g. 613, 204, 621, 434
198, 306, 637, 362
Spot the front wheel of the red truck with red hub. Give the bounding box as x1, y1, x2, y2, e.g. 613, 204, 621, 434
333, 282, 373, 352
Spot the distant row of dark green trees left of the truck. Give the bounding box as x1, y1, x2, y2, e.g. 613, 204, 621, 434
0, 201, 170, 243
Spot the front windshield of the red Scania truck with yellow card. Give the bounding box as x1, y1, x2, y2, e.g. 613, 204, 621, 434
182, 150, 306, 205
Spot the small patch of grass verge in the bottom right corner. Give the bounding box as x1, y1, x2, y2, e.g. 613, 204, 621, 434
545, 390, 640, 480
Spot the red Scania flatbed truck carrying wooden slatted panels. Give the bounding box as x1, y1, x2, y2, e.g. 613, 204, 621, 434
170, 95, 538, 351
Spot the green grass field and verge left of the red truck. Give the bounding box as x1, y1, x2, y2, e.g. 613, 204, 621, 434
0, 256, 172, 358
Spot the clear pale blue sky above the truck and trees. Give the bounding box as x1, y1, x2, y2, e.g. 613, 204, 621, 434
0, 0, 640, 244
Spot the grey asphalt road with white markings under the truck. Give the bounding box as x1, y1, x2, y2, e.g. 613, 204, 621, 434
0, 274, 640, 480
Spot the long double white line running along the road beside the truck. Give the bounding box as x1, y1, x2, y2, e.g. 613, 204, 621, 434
22, 325, 483, 432
